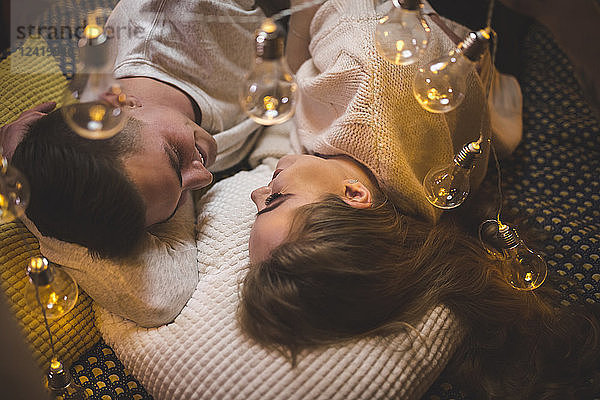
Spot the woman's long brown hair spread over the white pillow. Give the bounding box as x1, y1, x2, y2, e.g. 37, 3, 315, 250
239, 196, 600, 399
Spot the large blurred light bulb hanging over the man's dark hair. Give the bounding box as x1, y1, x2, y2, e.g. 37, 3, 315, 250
62, 11, 127, 139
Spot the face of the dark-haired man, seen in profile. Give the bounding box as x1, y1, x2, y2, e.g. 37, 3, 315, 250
123, 105, 217, 226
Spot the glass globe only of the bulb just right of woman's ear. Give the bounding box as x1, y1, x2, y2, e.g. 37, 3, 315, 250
423, 162, 471, 210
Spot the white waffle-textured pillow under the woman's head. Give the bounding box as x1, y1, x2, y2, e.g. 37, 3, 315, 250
96, 165, 462, 400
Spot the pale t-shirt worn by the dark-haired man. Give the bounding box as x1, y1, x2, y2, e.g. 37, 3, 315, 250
107, 0, 264, 171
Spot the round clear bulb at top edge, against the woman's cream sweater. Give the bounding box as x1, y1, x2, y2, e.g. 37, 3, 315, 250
375, 0, 431, 65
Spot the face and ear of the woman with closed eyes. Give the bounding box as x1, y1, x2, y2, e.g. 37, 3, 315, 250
249, 155, 371, 263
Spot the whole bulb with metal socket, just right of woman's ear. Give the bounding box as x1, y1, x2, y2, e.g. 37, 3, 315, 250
423, 142, 481, 210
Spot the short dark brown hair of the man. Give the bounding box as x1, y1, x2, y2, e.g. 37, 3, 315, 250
11, 110, 146, 259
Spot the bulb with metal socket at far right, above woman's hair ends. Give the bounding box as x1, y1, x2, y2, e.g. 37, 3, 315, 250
498, 224, 548, 290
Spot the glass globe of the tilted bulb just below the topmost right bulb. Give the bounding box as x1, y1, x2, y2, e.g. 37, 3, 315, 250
413, 51, 473, 113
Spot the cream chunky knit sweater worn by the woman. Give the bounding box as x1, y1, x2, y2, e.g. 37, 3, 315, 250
292, 0, 490, 221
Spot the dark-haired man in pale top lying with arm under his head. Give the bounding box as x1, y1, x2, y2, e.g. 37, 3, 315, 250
0, 0, 276, 326
